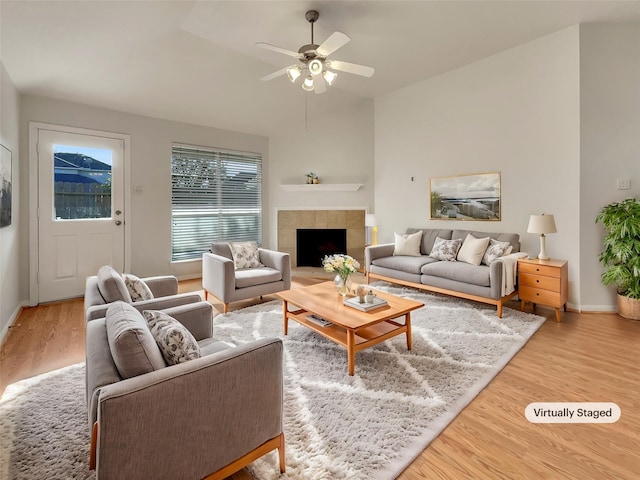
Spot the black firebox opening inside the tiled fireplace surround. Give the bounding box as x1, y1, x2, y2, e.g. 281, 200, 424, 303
296, 228, 347, 267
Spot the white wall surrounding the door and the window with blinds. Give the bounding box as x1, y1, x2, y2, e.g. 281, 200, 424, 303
20, 95, 269, 280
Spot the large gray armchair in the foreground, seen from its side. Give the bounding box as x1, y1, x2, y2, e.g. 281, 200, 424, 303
86, 301, 285, 480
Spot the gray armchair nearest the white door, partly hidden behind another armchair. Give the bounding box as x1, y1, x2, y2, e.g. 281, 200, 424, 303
84, 266, 202, 322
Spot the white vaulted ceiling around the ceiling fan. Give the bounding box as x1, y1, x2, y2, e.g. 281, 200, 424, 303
0, 0, 640, 135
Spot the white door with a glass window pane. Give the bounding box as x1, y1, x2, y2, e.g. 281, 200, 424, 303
36, 129, 125, 303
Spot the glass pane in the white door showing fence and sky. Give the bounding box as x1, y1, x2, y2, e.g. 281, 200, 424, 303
53, 145, 112, 220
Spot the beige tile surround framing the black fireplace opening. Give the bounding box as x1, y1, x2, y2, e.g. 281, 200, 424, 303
278, 209, 365, 268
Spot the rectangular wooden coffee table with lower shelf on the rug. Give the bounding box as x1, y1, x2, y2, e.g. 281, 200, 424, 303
277, 282, 424, 375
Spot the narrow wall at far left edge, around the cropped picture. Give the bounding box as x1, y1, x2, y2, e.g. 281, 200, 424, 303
0, 62, 21, 342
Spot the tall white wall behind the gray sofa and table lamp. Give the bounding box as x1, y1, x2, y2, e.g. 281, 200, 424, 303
375, 26, 580, 306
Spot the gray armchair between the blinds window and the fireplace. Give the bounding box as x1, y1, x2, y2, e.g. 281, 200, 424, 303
202, 243, 291, 313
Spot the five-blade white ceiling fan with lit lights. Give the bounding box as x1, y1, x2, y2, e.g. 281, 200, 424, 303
256, 10, 375, 93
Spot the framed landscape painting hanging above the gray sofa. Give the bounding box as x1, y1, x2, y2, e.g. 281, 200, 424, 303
430, 172, 500, 220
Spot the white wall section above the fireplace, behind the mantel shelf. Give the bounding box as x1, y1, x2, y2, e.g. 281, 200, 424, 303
268, 90, 374, 246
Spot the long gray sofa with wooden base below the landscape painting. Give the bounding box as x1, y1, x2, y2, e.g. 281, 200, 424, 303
365, 228, 520, 317
